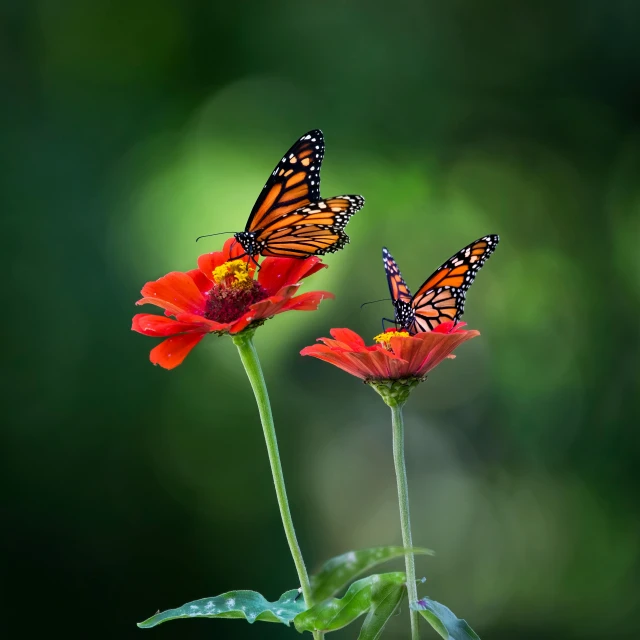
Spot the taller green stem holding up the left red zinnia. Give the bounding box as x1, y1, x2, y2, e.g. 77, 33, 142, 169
232, 331, 322, 638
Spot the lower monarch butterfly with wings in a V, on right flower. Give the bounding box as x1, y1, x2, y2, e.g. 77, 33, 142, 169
382, 235, 500, 335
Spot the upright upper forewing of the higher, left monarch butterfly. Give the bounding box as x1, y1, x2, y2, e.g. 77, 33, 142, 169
245, 129, 324, 232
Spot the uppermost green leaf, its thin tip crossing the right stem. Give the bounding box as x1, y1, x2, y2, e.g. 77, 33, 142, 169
311, 547, 433, 602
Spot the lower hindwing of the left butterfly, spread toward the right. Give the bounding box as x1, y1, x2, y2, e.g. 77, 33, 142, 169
256, 196, 364, 258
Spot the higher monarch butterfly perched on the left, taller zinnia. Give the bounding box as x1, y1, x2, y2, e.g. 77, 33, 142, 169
234, 129, 364, 258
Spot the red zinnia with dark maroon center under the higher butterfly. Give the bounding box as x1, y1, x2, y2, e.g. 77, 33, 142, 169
131, 238, 333, 369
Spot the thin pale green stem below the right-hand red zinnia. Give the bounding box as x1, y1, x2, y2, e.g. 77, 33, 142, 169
389, 402, 420, 640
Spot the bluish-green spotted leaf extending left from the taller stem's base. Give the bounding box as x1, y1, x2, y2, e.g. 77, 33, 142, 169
138, 589, 305, 629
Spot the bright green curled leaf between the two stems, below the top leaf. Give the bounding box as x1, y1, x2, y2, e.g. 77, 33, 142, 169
293, 573, 406, 638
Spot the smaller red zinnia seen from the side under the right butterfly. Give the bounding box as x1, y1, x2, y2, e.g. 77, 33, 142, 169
300, 322, 480, 399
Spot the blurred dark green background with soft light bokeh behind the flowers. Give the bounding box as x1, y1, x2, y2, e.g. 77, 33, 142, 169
0, 0, 640, 640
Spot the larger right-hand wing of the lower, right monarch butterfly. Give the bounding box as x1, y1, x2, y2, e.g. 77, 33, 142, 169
409, 235, 500, 334
